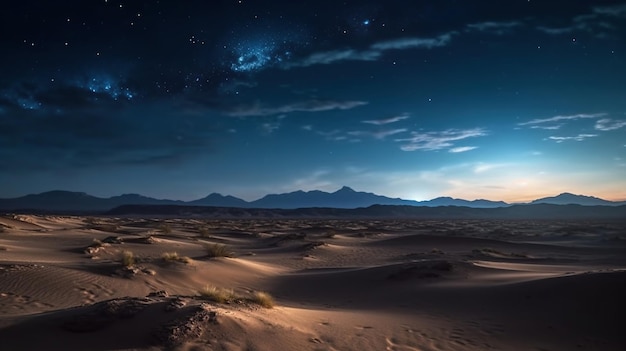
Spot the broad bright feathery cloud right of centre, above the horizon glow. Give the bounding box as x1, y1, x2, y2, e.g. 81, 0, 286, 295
396, 128, 487, 151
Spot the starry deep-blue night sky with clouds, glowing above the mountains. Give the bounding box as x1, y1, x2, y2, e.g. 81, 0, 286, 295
0, 0, 626, 202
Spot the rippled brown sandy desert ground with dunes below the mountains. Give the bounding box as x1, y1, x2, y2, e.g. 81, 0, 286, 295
0, 215, 626, 351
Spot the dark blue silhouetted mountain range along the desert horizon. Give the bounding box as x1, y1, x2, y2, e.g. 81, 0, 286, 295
0, 186, 626, 212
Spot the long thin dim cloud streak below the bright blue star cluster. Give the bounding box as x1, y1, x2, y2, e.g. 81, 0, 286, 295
226, 100, 367, 117
